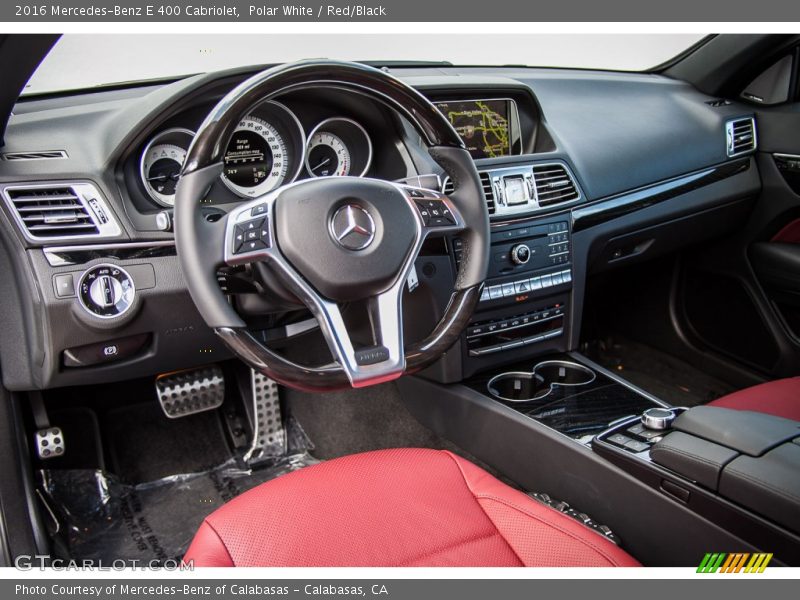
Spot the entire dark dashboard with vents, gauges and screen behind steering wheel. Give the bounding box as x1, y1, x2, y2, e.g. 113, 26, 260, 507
0, 67, 760, 390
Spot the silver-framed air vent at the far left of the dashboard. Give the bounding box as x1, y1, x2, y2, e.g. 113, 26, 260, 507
3, 183, 121, 241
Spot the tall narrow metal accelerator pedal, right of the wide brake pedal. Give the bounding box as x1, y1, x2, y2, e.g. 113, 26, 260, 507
243, 369, 286, 463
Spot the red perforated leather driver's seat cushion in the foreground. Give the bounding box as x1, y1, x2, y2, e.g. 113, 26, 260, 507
185, 449, 638, 567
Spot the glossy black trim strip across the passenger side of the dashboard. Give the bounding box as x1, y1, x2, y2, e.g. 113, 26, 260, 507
572, 156, 750, 233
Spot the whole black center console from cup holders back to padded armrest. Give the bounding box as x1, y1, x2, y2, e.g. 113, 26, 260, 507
398, 353, 800, 567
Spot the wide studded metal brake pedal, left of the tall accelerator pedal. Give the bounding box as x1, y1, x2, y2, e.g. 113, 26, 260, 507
156, 365, 225, 419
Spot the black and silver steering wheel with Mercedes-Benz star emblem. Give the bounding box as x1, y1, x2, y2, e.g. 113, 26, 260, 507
175, 61, 489, 391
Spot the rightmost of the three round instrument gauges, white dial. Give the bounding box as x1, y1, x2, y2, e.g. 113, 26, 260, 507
305, 117, 372, 177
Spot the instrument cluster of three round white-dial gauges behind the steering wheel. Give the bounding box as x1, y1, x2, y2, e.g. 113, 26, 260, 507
139, 100, 372, 207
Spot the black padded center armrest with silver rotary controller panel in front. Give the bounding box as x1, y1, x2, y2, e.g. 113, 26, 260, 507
592, 406, 800, 560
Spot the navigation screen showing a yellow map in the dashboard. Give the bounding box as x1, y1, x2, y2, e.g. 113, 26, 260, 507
436, 100, 511, 158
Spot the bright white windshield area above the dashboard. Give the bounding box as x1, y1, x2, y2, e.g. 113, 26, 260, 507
24, 33, 704, 94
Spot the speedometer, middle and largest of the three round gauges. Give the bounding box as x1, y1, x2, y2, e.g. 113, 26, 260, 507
222, 115, 291, 196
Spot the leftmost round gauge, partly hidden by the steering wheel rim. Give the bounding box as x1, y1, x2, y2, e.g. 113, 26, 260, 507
140, 129, 194, 206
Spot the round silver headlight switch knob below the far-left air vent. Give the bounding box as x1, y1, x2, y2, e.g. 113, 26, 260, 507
78, 265, 136, 319
